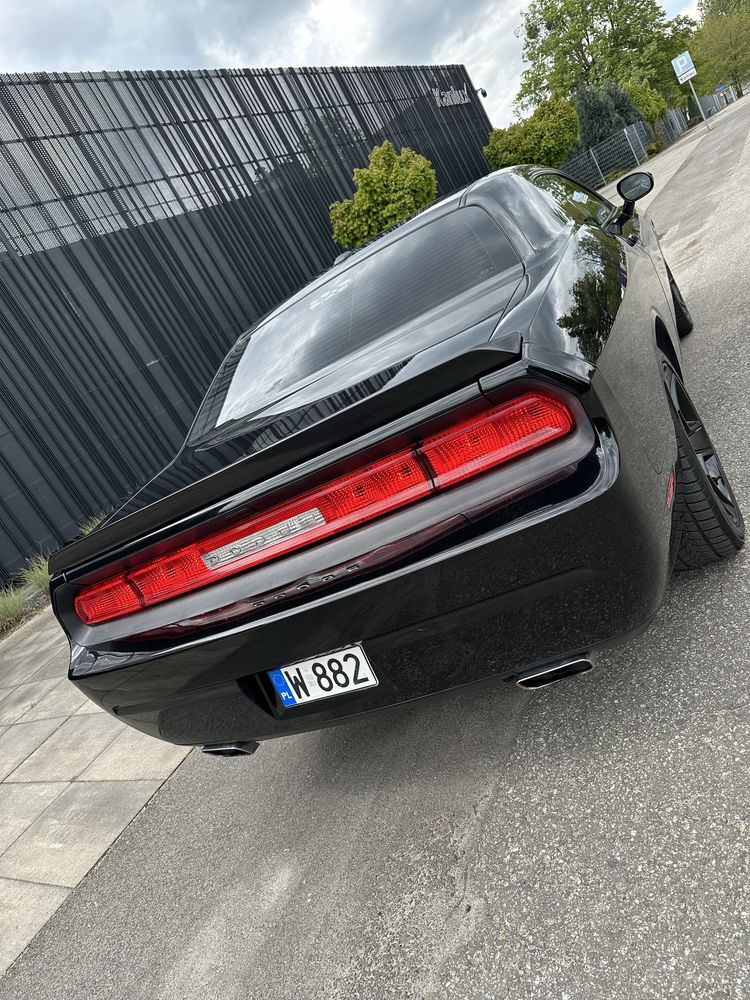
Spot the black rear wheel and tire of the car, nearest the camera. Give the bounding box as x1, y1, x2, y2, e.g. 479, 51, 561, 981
664, 361, 745, 571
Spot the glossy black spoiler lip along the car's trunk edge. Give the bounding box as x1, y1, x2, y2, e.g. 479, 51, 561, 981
49, 333, 522, 576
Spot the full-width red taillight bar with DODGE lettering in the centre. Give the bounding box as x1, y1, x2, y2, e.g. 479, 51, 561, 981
75, 393, 573, 625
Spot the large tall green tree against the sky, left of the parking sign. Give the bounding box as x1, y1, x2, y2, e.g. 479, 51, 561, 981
517, 0, 704, 108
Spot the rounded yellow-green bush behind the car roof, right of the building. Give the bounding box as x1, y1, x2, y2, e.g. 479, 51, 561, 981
484, 98, 578, 170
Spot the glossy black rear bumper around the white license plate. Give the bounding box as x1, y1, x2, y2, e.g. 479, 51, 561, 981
66, 408, 670, 744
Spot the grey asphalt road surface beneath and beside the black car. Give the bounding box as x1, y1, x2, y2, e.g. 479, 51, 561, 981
5, 98, 750, 1000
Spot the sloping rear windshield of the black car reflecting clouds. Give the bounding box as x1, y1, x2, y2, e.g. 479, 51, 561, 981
190, 206, 518, 444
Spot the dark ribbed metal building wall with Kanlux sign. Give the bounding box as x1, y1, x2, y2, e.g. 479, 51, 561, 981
0, 66, 490, 581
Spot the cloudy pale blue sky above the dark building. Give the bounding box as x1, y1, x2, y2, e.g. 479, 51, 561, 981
0, 0, 697, 127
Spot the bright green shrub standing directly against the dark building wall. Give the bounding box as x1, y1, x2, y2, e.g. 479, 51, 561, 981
331, 139, 437, 247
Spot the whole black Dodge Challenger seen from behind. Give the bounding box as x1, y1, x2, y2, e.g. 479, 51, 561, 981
50, 167, 744, 754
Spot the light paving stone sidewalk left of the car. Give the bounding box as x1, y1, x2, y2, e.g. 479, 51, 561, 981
0, 609, 189, 975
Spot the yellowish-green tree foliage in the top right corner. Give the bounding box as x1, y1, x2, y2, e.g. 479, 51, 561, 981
695, 0, 750, 94
